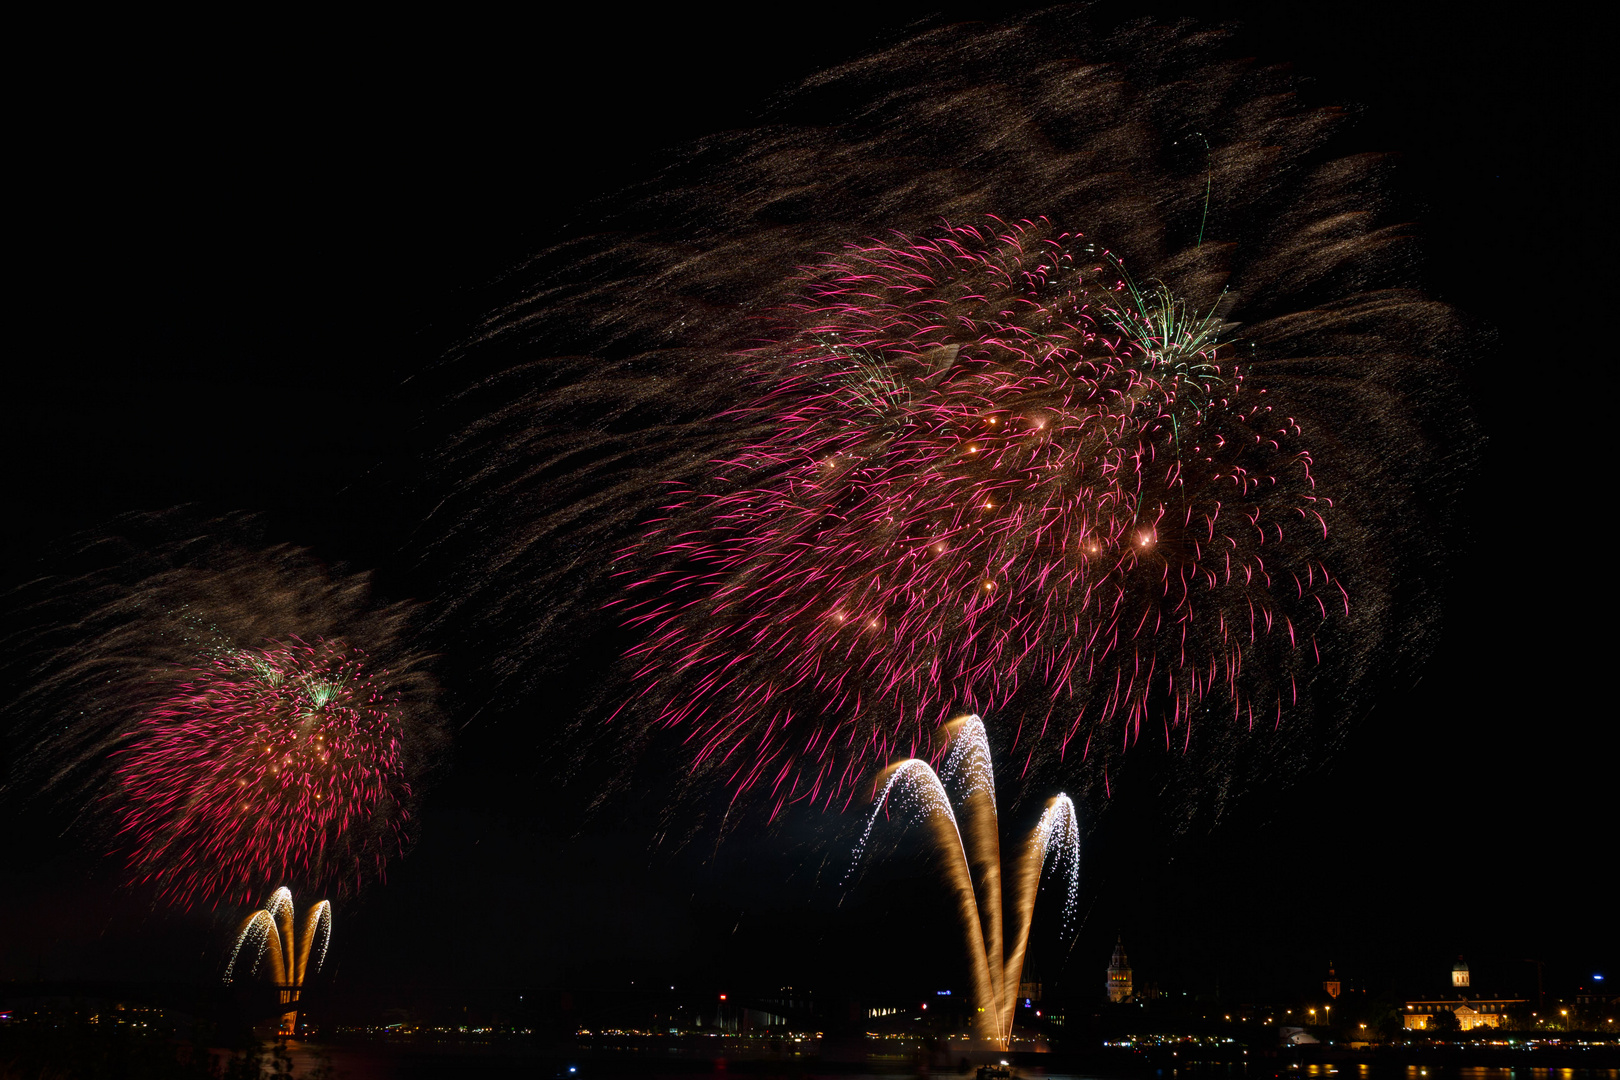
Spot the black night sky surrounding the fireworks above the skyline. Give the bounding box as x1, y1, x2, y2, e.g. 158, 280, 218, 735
0, 0, 1620, 1016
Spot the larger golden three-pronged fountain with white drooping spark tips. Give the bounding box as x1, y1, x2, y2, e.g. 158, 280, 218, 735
855, 716, 1081, 1051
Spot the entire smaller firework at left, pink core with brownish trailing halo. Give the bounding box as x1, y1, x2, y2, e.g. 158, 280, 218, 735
6, 518, 442, 907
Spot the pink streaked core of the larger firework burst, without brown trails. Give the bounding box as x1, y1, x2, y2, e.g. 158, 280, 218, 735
619, 222, 1349, 810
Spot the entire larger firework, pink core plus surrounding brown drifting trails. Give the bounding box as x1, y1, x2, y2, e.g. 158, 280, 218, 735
431, 10, 1473, 821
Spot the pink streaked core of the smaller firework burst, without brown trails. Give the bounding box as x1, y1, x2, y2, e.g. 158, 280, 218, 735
113, 638, 411, 905
